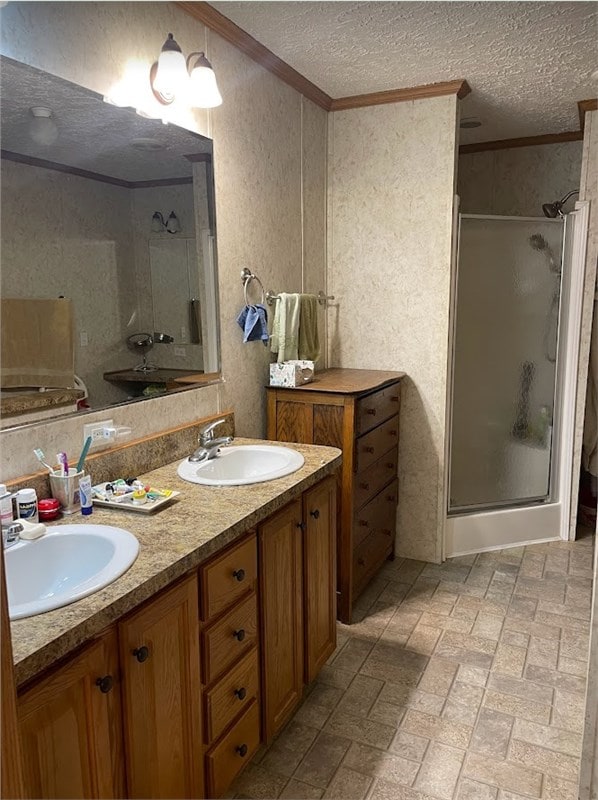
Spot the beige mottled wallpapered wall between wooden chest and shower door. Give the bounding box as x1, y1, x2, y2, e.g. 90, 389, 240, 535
328, 96, 457, 561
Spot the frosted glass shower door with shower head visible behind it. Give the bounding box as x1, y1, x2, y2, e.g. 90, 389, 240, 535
449, 215, 563, 513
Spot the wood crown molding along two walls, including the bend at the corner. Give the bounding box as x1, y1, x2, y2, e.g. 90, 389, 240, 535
174, 0, 471, 111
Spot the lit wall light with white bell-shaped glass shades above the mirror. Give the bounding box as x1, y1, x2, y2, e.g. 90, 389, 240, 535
150, 33, 222, 108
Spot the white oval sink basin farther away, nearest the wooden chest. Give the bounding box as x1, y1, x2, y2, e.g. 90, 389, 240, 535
177, 444, 305, 486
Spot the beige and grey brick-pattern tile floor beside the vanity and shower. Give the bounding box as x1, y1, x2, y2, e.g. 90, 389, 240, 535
227, 536, 593, 800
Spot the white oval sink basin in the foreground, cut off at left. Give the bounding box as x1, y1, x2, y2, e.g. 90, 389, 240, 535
4, 524, 139, 619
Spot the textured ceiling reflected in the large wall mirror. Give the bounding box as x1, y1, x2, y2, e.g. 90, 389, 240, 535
0, 58, 211, 182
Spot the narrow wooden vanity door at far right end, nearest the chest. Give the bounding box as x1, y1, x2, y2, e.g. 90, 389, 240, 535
303, 478, 336, 683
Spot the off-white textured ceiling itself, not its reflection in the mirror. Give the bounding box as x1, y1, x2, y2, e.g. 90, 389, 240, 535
211, 0, 598, 142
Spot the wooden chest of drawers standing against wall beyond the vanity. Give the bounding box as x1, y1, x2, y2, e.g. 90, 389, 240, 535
267, 369, 404, 623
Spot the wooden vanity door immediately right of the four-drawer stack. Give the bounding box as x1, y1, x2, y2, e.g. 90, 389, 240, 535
259, 500, 303, 739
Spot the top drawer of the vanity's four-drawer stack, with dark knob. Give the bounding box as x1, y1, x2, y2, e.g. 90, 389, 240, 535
199, 534, 257, 622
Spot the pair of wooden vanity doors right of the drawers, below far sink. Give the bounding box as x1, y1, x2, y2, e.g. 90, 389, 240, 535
258, 477, 336, 741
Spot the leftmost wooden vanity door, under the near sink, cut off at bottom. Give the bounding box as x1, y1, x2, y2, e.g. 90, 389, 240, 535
18, 629, 125, 798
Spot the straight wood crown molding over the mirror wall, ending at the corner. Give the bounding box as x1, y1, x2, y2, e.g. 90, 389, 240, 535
174, 2, 332, 111
